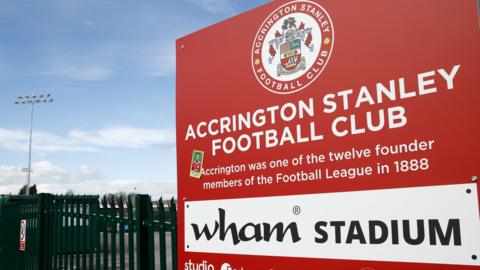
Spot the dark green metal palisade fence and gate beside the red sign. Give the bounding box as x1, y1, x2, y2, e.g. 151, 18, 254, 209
0, 194, 177, 270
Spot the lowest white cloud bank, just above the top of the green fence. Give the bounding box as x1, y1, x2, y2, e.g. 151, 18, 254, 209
0, 161, 177, 198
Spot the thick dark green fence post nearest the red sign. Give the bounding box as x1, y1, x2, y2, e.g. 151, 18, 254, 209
135, 195, 150, 269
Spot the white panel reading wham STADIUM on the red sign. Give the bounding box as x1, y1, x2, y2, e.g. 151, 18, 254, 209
185, 184, 480, 265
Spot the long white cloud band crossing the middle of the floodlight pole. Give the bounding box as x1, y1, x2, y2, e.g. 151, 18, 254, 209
0, 127, 175, 153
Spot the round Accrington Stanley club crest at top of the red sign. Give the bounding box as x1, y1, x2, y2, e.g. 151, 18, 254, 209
252, 1, 333, 94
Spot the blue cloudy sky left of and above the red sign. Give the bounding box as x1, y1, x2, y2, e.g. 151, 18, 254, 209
0, 0, 268, 197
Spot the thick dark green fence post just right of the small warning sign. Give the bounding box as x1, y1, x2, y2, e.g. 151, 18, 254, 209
37, 193, 50, 270
